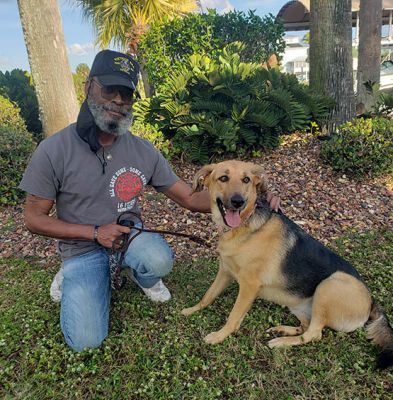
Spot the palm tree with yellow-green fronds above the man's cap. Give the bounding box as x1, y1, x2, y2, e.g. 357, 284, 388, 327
75, 0, 197, 96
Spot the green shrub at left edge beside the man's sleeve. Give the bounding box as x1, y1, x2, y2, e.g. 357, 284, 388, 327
0, 126, 36, 205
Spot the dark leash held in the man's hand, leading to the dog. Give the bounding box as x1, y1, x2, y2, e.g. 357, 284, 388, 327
105, 211, 208, 290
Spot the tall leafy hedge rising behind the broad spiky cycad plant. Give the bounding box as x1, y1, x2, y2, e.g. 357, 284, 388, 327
139, 10, 285, 89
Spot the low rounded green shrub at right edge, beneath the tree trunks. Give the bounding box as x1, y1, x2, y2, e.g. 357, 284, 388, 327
321, 118, 393, 176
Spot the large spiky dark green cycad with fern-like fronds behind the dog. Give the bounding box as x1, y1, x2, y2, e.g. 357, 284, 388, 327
135, 42, 332, 163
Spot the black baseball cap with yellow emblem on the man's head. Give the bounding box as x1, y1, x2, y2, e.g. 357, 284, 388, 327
89, 50, 139, 90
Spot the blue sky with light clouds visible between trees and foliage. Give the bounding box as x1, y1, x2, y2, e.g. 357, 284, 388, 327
0, 0, 288, 72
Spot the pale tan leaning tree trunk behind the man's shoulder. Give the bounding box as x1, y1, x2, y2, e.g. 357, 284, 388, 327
18, 0, 79, 136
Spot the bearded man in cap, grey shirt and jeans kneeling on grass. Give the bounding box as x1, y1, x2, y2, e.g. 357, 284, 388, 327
20, 50, 279, 351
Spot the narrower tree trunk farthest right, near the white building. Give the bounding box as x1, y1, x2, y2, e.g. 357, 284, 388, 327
357, 0, 382, 112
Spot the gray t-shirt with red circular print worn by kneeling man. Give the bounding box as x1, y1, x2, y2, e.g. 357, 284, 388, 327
19, 124, 179, 259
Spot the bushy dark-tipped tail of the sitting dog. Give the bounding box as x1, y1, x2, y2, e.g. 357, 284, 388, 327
366, 300, 393, 369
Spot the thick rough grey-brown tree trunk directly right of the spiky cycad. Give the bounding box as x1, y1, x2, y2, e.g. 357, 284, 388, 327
309, 0, 355, 134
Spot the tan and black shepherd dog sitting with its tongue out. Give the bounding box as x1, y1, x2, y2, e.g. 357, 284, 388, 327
182, 160, 393, 368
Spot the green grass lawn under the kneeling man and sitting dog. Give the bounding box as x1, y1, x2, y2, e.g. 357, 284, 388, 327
0, 231, 393, 400
